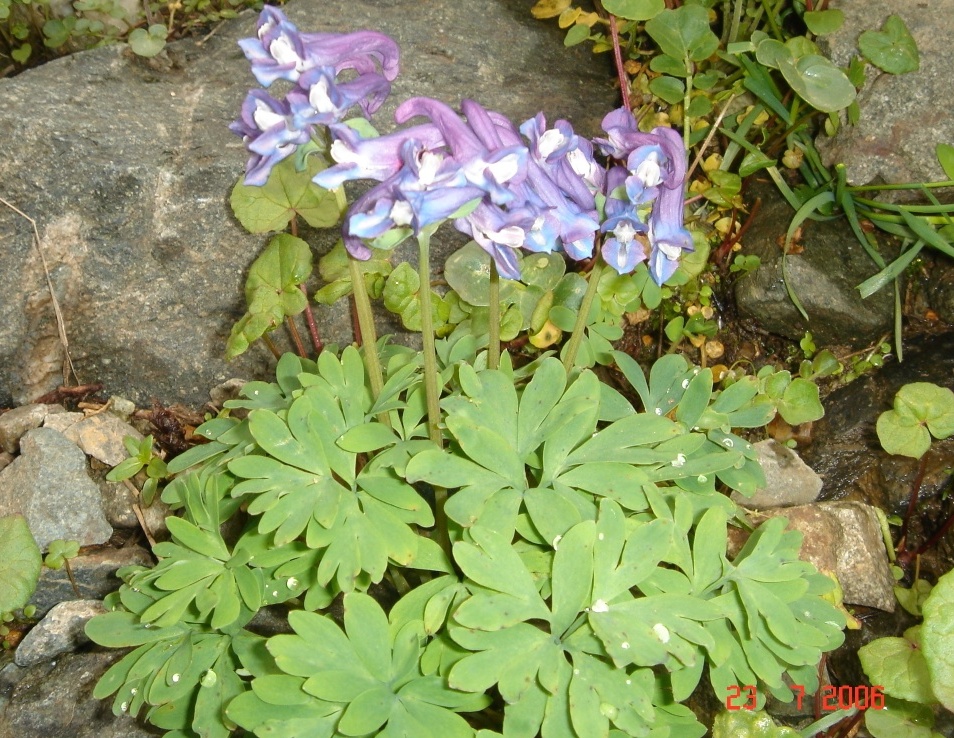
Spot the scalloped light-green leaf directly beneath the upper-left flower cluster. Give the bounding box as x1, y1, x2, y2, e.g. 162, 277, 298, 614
230, 156, 341, 233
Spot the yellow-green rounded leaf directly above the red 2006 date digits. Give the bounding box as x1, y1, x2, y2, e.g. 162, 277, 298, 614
858, 627, 928, 704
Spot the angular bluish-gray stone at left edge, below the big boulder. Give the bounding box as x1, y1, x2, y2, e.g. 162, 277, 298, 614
0, 428, 113, 550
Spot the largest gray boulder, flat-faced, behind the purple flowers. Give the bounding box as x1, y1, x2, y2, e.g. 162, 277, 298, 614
0, 0, 617, 405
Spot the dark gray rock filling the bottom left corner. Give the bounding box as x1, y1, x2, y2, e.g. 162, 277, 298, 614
0, 651, 156, 738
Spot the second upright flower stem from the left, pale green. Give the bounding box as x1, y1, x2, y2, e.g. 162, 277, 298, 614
417, 228, 453, 561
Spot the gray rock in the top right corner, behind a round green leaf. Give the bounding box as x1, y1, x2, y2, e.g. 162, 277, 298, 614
817, 0, 954, 196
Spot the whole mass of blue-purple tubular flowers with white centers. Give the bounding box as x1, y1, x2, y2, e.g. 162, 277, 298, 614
232, 7, 692, 284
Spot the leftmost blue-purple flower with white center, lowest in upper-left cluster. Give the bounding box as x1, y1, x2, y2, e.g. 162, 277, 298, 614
229, 90, 311, 186
